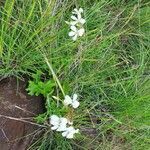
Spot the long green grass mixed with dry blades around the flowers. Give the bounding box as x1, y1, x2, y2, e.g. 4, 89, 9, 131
0, 0, 150, 150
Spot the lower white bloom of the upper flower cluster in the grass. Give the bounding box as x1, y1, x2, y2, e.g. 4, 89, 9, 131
69, 26, 85, 41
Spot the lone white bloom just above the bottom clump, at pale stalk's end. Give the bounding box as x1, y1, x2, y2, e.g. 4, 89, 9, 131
64, 94, 80, 108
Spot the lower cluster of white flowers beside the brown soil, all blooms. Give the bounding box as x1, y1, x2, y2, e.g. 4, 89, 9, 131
50, 94, 80, 139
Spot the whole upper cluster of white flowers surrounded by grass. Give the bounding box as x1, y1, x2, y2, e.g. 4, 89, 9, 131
66, 8, 86, 41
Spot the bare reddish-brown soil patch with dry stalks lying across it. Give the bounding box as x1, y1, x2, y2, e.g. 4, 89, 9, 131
0, 78, 44, 150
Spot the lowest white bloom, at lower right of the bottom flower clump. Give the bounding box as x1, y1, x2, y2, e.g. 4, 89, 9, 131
62, 126, 79, 139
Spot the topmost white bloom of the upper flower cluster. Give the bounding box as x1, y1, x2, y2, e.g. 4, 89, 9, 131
70, 8, 86, 26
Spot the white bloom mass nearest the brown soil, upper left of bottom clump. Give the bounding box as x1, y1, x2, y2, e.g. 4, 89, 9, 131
50, 115, 68, 131
